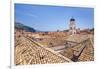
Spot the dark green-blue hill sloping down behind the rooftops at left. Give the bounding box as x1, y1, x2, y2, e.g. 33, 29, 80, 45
15, 22, 36, 32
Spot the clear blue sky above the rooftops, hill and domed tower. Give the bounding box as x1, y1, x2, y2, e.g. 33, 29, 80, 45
14, 3, 94, 31
